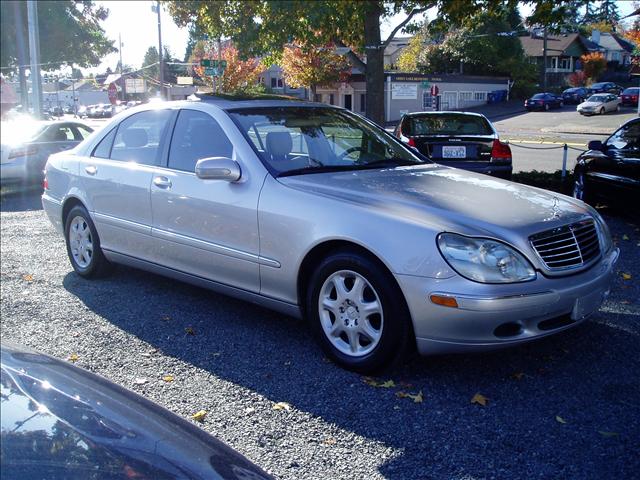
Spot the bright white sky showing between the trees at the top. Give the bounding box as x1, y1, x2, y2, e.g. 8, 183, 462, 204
91, 0, 633, 73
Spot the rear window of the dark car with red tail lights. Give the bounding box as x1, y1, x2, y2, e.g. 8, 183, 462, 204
403, 113, 493, 135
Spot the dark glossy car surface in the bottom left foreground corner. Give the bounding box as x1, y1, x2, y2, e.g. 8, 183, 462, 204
0, 344, 271, 480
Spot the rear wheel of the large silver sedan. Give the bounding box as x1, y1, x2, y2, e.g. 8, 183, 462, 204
64, 205, 112, 278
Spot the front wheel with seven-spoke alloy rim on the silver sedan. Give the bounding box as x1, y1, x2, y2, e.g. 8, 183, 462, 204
306, 250, 412, 373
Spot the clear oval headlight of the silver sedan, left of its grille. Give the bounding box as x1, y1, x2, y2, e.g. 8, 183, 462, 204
438, 233, 536, 283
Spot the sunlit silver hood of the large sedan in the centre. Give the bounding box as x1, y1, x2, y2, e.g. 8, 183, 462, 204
279, 164, 590, 239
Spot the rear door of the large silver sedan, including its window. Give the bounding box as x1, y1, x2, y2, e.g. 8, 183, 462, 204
79, 109, 175, 260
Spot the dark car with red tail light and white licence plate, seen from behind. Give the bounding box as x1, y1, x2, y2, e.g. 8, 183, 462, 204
395, 112, 512, 179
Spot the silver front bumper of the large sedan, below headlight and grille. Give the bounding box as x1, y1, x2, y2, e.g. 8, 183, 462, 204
396, 249, 619, 355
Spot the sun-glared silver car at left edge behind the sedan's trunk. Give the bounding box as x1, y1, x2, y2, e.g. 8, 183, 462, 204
0, 121, 93, 184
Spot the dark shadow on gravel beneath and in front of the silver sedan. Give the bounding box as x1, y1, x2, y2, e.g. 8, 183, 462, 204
63, 260, 640, 480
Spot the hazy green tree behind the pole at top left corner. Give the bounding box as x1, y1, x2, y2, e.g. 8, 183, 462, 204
0, 0, 116, 70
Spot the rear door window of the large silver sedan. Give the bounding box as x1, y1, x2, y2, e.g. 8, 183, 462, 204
110, 110, 171, 165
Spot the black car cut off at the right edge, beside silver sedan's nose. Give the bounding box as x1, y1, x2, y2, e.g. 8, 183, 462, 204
573, 118, 640, 207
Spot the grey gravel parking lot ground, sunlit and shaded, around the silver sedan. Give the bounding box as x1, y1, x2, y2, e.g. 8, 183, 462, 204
0, 192, 640, 480
